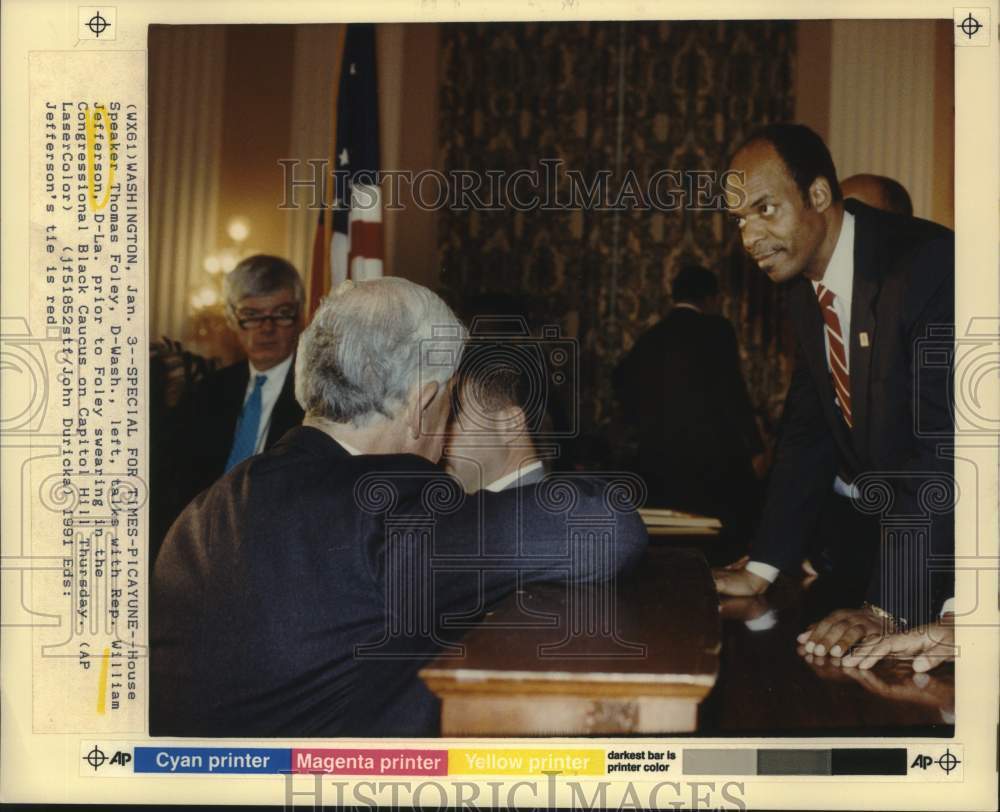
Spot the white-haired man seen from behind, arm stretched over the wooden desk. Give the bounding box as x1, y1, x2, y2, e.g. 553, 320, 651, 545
150, 278, 647, 737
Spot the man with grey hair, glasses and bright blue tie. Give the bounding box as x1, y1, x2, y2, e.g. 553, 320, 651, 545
151, 254, 304, 558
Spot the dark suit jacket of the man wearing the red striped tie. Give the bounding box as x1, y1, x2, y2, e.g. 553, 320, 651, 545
751, 200, 955, 623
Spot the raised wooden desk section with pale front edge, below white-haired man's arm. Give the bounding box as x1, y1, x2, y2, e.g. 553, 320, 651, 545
420, 547, 720, 736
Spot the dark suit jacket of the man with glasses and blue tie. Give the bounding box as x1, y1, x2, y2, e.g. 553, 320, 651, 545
150, 358, 303, 560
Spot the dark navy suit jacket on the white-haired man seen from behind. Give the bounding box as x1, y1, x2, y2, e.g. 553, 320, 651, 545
150, 427, 647, 737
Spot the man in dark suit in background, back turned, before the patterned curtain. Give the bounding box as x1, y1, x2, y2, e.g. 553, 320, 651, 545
615, 265, 763, 533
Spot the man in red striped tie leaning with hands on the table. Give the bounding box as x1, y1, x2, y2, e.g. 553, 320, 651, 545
716, 124, 954, 658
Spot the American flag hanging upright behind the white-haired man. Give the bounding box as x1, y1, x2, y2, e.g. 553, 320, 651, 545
309, 24, 383, 313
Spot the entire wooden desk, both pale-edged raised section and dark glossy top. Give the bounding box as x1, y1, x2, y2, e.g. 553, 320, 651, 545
421, 536, 955, 737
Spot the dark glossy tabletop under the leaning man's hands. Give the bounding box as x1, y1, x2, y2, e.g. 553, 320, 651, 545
696, 576, 955, 737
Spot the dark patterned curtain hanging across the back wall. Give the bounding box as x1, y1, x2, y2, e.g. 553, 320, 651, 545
440, 22, 795, 465
